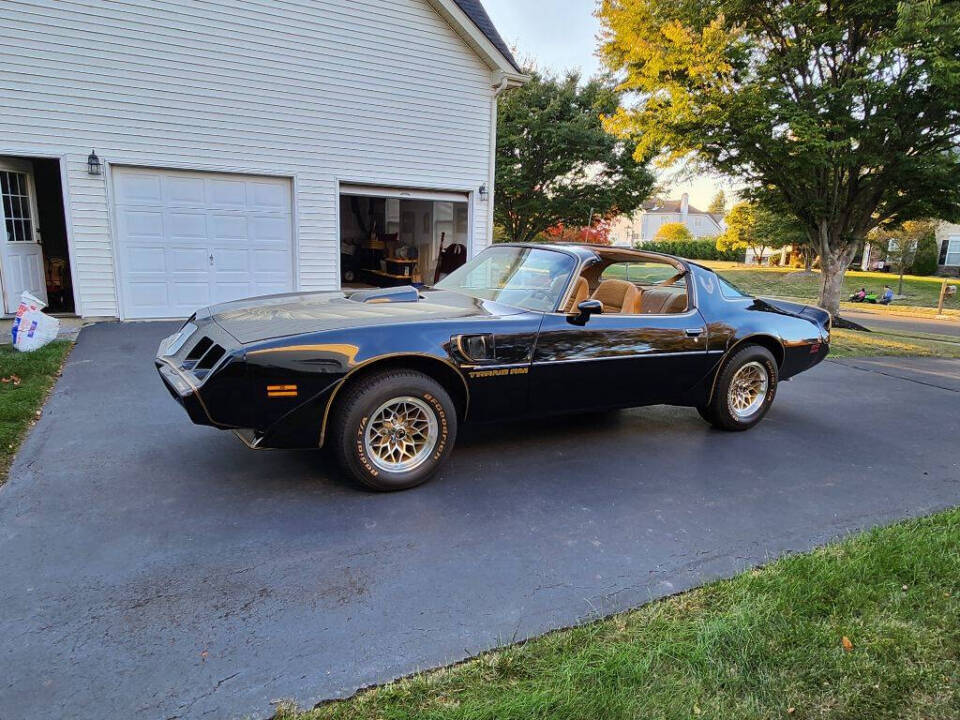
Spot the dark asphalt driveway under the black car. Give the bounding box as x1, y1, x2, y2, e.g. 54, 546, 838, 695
0, 324, 960, 720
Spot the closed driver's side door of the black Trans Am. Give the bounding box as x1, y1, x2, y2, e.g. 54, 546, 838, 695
530, 263, 709, 414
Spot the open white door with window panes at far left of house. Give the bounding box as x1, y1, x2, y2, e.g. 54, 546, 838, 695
0, 158, 47, 313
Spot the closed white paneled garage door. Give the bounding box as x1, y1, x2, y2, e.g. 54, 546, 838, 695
113, 168, 294, 319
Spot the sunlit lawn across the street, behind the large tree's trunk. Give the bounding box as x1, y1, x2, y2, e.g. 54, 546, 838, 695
704, 263, 960, 310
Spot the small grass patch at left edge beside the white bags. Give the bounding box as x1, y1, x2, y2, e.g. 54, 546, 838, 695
0, 340, 71, 484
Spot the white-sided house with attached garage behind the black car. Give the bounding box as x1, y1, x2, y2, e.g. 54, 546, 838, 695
0, 0, 525, 319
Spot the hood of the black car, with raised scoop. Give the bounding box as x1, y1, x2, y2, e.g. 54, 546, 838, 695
196, 288, 525, 344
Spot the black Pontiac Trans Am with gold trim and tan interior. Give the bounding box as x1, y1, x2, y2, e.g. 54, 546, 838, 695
156, 244, 830, 490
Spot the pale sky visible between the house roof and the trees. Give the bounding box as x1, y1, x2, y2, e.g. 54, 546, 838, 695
483, 0, 734, 210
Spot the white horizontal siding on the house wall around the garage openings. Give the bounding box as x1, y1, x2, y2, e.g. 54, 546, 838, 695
0, 0, 493, 316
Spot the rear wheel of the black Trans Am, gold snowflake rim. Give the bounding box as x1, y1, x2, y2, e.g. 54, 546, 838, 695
697, 345, 779, 432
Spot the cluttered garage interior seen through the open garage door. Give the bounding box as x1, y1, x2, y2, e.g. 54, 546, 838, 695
340, 191, 470, 288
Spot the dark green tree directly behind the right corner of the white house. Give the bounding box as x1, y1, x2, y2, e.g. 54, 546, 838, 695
494, 71, 654, 242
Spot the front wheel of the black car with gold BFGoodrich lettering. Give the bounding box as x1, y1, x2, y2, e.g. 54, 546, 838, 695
331, 370, 457, 492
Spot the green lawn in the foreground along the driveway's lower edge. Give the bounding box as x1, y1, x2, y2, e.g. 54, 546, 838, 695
277, 509, 960, 720
